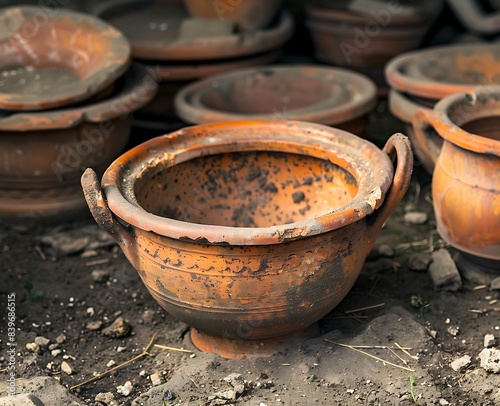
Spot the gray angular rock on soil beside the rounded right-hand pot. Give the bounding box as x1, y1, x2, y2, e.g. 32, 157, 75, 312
429, 249, 462, 291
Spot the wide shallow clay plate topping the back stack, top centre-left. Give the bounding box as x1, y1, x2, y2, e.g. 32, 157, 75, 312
95, 0, 293, 61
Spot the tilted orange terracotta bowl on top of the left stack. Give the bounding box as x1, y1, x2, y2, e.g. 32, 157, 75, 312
0, 6, 130, 110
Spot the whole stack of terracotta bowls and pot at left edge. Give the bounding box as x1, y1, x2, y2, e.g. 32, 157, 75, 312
0, 7, 156, 219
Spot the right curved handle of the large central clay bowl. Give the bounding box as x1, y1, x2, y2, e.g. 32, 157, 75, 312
366, 133, 413, 255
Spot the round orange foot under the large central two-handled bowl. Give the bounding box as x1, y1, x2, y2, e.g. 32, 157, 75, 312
191, 323, 320, 359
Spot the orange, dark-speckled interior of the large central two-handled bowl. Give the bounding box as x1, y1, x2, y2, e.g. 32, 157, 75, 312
134, 151, 358, 227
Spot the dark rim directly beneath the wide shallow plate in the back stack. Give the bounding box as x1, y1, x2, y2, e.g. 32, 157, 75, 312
148, 49, 282, 82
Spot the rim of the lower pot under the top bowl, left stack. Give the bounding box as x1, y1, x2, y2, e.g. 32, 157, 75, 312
0, 63, 158, 134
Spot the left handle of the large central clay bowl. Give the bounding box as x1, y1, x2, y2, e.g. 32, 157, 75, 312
81, 168, 137, 267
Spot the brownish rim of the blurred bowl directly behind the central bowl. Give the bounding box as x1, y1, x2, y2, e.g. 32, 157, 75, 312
174, 65, 377, 125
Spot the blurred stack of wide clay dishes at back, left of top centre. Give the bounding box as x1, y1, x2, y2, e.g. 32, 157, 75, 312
95, 0, 293, 120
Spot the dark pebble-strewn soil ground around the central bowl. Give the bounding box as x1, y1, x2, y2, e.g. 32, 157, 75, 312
0, 101, 500, 406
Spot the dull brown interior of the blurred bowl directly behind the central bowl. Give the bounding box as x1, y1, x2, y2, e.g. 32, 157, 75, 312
198, 70, 338, 114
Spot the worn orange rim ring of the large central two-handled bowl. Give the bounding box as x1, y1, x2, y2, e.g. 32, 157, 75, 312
101, 121, 394, 245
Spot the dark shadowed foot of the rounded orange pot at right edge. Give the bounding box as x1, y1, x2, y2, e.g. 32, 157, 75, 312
454, 251, 500, 285
